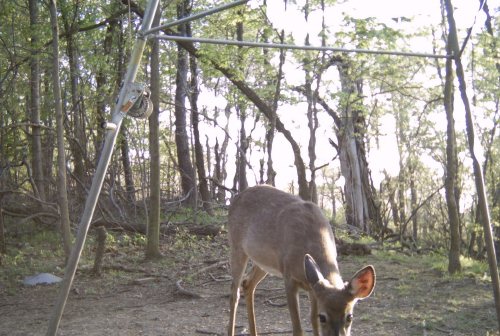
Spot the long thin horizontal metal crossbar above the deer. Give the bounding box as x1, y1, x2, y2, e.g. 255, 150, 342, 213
154, 35, 453, 58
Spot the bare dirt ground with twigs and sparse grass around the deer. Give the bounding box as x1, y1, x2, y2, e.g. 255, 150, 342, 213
0, 230, 497, 336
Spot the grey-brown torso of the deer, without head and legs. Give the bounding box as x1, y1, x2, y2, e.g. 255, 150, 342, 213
228, 186, 342, 288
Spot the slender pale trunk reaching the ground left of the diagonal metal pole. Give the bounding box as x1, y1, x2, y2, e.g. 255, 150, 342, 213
49, 0, 71, 259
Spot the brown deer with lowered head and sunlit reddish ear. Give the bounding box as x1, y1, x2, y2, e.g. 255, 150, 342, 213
228, 185, 375, 336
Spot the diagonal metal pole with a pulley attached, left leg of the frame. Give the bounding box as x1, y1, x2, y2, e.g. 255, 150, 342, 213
46, 0, 159, 336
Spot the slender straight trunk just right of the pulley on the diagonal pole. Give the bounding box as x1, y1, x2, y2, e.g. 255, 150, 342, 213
146, 6, 161, 259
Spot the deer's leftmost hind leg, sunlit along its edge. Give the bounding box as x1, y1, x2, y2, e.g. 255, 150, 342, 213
227, 249, 248, 336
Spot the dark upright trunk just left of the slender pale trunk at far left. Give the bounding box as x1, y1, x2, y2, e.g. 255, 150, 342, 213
29, 0, 46, 201
